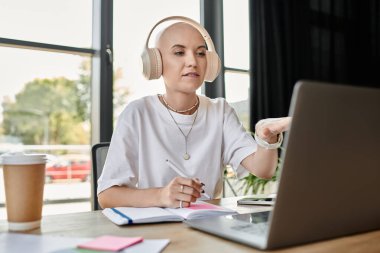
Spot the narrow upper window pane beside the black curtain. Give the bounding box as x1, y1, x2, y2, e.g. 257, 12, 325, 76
223, 0, 249, 70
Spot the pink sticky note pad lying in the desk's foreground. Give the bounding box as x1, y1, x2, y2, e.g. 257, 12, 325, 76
77, 235, 144, 251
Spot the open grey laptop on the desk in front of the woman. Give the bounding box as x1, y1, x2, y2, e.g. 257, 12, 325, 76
185, 81, 380, 249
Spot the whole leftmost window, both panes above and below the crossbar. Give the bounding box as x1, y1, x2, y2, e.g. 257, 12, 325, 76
0, 0, 93, 219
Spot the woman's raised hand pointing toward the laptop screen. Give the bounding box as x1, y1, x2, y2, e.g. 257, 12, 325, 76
255, 117, 292, 143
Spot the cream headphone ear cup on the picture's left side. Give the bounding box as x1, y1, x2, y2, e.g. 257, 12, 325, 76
141, 48, 162, 80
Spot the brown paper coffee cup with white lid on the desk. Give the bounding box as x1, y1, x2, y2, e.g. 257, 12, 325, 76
0, 153, 46, 231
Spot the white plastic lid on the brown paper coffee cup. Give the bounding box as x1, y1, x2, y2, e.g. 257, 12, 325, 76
0, 152, 47, 165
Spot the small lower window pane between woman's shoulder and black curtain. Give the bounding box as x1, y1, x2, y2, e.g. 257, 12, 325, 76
224, 71, 250, 130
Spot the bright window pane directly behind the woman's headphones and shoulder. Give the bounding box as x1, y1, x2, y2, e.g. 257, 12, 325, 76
113, 0, 200, 118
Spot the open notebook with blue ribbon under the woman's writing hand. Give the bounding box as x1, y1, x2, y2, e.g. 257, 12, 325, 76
103, 201, 237, 225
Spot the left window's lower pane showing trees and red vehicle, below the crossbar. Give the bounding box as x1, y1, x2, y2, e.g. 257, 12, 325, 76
0, 47, 91, 219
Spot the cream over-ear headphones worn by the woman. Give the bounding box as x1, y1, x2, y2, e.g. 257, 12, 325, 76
141, 16, 221, 82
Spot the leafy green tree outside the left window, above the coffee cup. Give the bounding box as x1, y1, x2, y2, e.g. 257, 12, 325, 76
3, 77, 89, 144
